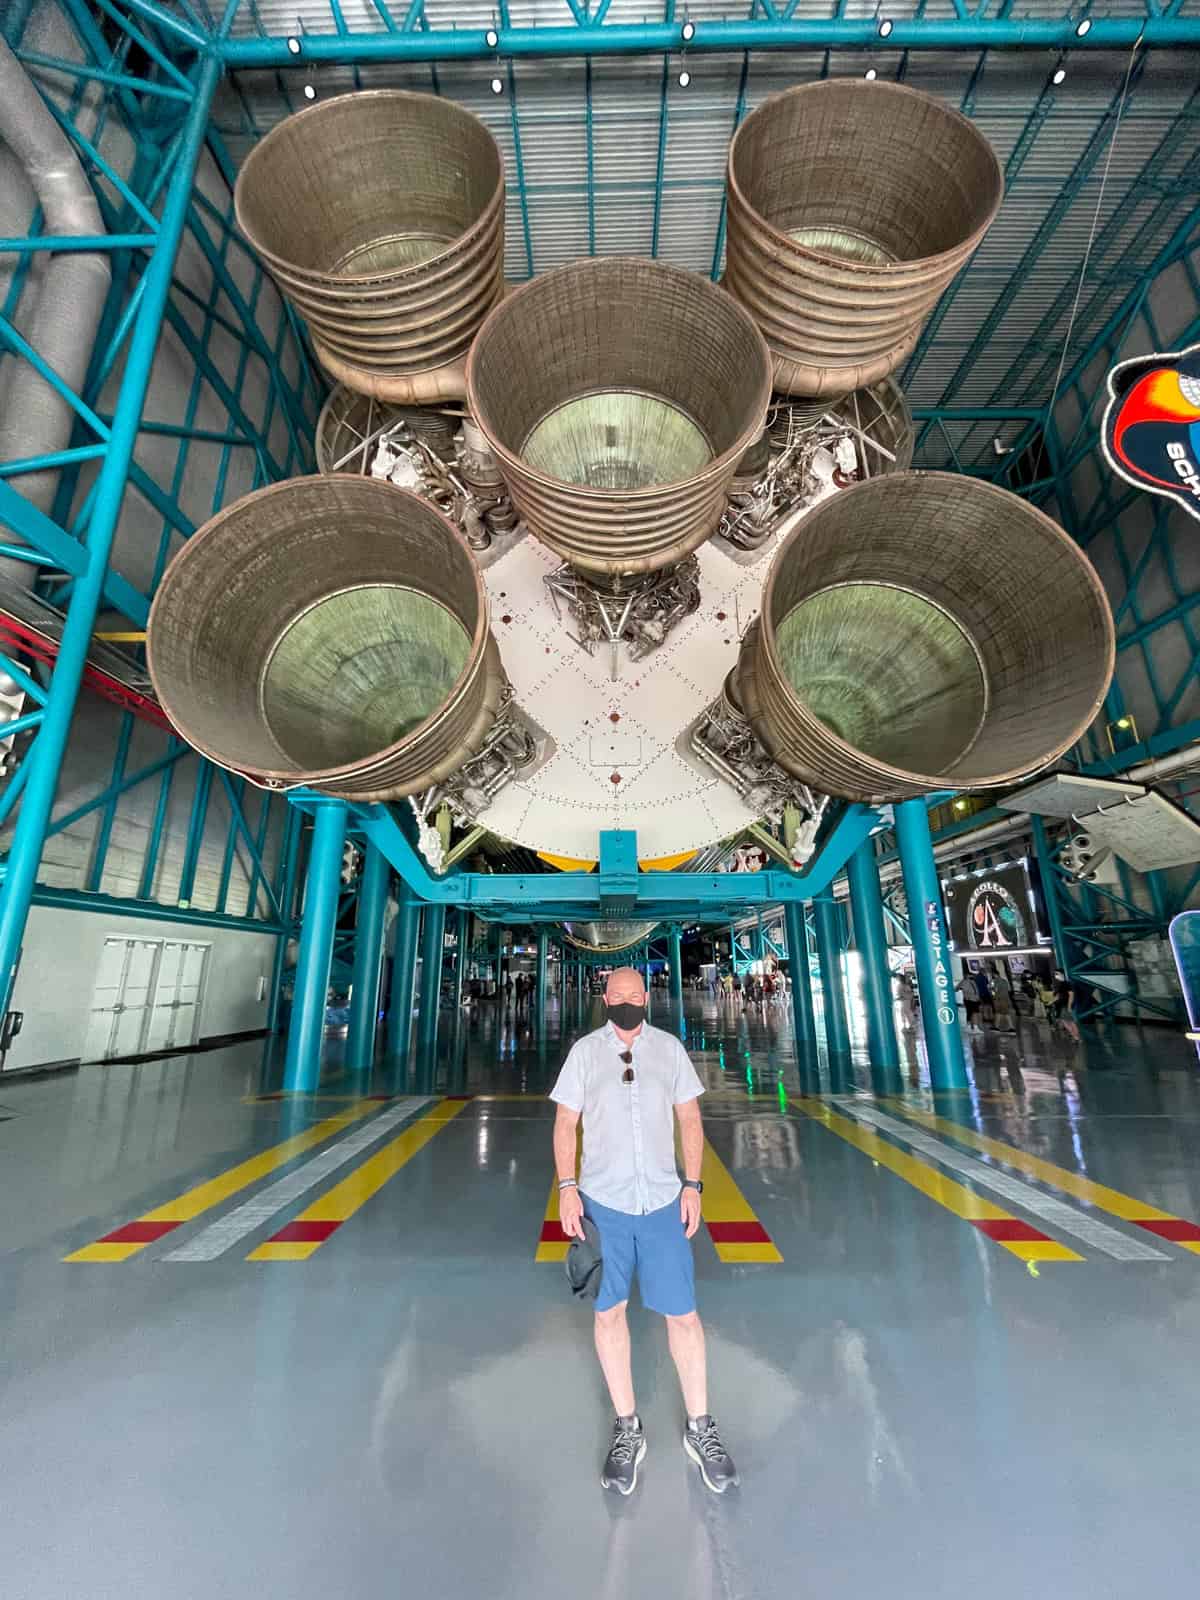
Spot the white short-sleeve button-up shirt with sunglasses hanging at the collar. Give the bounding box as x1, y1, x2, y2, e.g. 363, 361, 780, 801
550, 1022, 704, 1214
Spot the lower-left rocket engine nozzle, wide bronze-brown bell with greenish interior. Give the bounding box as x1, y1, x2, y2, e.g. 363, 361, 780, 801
146, 474, 507, 800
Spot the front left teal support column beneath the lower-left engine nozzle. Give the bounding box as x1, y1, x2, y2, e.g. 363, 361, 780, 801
283, 800, 346, 1094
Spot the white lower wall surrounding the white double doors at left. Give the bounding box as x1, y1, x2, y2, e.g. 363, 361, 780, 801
5, 906, 275, 1070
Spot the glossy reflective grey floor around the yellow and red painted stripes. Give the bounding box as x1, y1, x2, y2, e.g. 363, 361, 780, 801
0, 1000, 1200, 1600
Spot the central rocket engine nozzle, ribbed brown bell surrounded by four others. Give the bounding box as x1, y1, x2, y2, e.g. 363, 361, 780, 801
467, 256, 771, 576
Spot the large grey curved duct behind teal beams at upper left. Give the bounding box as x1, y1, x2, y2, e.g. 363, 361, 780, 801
0, 38, 112, 587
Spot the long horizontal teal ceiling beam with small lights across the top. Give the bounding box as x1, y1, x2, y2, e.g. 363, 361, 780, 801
221, 18, 1200, 70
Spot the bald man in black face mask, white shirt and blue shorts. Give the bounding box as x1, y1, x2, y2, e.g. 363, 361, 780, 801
550, 966, 738, 1494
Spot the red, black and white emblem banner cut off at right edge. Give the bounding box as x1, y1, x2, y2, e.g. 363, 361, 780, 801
1101, 344, 1200, 517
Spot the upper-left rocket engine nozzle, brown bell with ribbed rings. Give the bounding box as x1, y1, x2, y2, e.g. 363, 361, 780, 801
234, 90, 504, 405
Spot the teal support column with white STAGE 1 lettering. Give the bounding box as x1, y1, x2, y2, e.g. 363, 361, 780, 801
894, 800, 966, 1090
